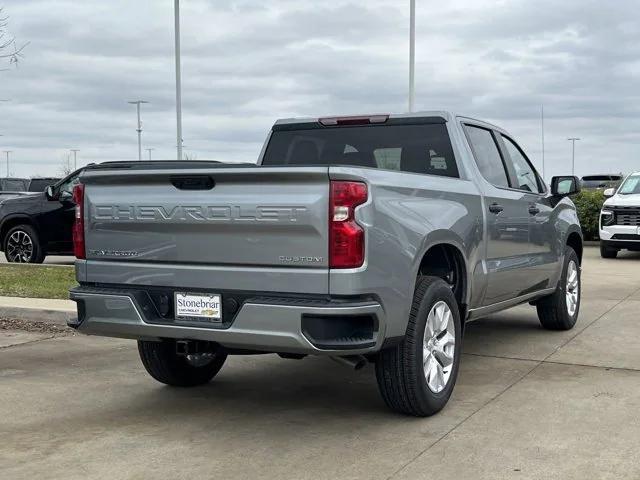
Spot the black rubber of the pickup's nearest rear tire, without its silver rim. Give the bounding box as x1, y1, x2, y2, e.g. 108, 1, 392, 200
376, 276, 462, 417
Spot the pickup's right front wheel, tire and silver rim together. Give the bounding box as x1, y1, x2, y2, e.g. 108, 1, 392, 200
536, 247, 582, 330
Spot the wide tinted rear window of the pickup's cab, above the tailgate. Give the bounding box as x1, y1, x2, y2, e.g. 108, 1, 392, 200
262, 123, 459, 177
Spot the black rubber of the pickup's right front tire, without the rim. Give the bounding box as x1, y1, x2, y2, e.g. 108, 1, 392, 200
536, 247, 582, 330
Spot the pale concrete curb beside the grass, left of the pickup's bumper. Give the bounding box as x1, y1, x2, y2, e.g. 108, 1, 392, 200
0, 297, 77, 325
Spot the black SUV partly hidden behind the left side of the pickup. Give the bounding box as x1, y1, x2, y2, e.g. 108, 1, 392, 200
0, 169, 82, 263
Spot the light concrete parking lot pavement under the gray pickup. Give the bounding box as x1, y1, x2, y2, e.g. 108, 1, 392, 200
0, 248, 640, 480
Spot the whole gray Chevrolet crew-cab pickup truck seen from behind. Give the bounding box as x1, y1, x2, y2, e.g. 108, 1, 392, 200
71, 112, 582, 416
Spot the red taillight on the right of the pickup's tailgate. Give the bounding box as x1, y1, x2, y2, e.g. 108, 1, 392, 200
329, 181, 367, 268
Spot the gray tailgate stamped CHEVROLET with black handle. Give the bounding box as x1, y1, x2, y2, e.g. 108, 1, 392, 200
82, 166, 329, 293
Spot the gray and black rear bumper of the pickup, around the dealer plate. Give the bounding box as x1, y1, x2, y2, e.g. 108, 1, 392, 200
69, 287, 386, 355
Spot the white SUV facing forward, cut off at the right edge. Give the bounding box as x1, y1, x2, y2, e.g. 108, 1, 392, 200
600, 172, 640, 258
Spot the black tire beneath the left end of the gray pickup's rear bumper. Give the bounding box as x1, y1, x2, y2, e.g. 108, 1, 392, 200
138, 340, 227, 387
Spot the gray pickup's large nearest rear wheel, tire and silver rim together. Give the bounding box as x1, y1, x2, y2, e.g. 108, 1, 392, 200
376, 276, 462, 417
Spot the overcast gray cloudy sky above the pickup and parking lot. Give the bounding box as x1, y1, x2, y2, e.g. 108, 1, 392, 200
0, 0, 640, 179
